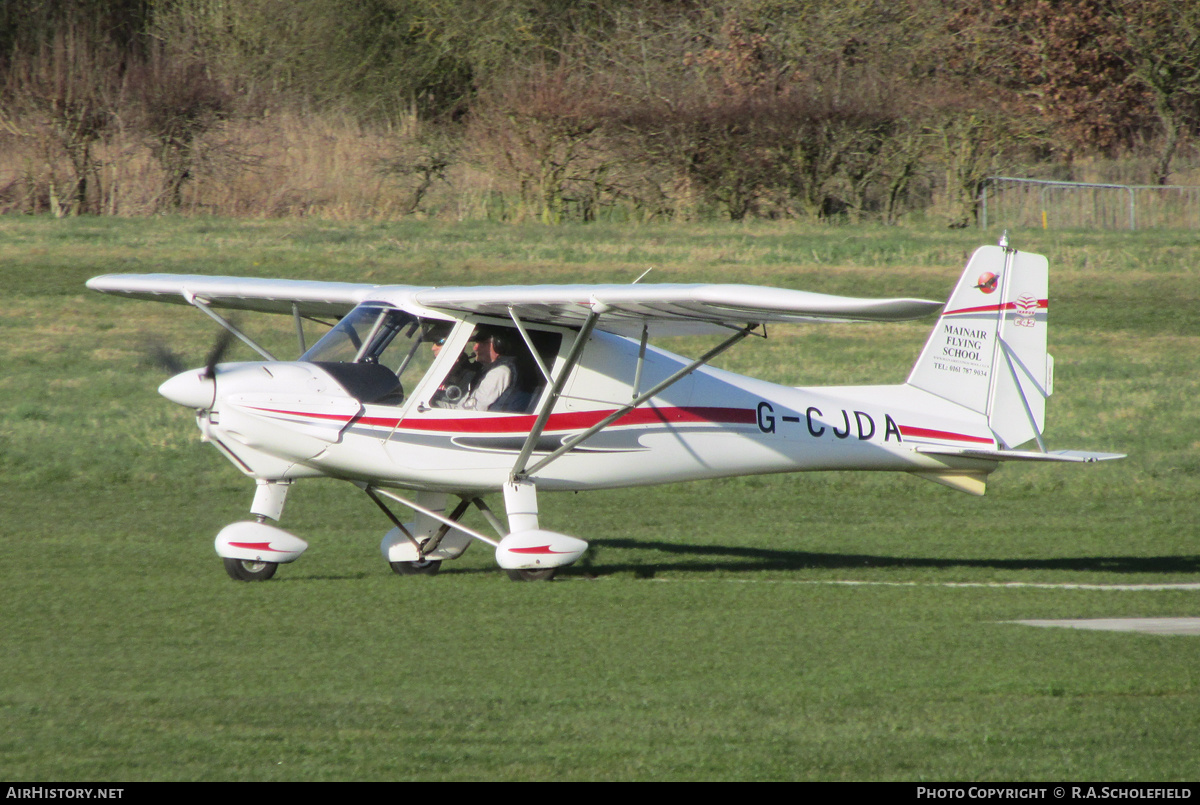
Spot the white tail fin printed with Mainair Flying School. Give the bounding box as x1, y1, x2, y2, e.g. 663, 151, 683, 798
908, 246, 1054, 451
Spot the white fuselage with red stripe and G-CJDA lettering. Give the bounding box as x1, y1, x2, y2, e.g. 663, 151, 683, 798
177, 332, 995, 492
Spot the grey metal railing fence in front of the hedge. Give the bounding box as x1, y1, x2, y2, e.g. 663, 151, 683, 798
979, 176, 1200, 230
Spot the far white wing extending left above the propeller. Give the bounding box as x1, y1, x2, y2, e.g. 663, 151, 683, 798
88, 274, 379, 317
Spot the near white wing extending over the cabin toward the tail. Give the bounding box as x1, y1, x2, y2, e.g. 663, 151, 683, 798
412, 284, 942, 335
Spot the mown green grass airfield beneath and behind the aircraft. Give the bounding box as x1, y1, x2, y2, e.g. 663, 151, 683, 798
0, 218, 1200, 781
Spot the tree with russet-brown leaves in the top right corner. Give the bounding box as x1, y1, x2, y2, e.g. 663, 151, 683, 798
947, 0, 1200, 184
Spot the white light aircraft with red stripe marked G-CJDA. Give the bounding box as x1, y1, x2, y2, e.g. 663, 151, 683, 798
88, 240, 1121, 581
